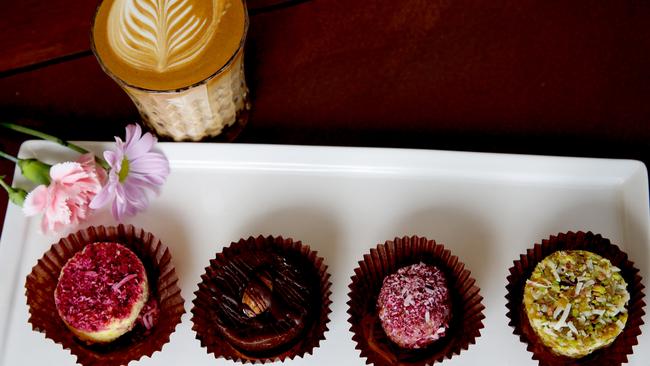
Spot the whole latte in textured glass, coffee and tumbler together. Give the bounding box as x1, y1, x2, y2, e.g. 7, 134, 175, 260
91, 0, 250, 141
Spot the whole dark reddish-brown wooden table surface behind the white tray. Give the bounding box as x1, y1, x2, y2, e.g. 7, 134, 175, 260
0, 0, 650, 234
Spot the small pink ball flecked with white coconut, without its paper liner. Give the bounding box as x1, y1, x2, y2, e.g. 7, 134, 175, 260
377, 263, 451, 349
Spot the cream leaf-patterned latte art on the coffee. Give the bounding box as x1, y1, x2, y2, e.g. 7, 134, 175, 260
107, 0, 224, 73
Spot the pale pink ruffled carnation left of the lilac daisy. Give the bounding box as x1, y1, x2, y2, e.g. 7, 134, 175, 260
23, 154, 106, 232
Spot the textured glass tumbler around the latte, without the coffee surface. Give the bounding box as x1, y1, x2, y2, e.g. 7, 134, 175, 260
91, 0, 251, 141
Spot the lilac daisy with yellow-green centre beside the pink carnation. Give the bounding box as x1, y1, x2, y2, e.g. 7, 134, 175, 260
90, 125, 169, 221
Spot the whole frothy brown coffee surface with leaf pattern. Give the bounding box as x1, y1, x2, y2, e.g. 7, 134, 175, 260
93, 0, 246, 90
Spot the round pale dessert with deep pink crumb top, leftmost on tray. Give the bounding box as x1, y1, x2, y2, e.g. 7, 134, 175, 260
54, 243, 149, 343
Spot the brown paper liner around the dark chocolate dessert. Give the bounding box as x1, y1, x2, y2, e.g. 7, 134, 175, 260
191, 235, 332, 363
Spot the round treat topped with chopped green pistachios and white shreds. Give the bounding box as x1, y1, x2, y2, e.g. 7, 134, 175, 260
524, 250, 630, 358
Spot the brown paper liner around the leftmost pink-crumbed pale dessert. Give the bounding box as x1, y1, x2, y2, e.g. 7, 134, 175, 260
25, 225, 185, 366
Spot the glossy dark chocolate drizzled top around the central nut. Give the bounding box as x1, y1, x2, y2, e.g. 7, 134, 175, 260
214, 251, 314, 352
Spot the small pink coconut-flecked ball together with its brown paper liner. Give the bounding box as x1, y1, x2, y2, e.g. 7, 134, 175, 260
348, 235, 485, 366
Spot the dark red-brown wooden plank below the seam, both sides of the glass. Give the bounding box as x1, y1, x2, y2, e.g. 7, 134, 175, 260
0, 0, 650, 141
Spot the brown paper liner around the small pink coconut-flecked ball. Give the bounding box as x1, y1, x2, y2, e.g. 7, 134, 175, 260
348, 236, 485, 366
